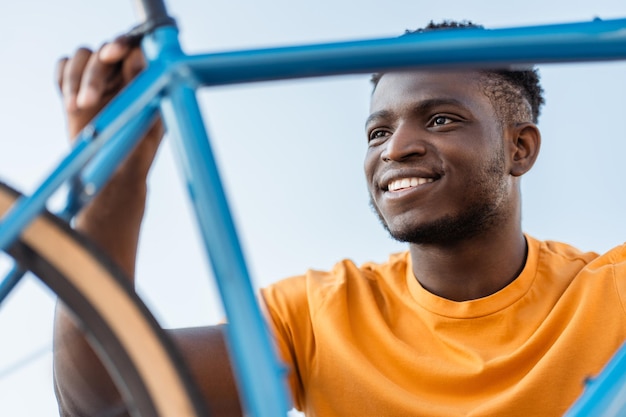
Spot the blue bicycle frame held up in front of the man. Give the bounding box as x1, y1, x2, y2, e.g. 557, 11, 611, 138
0, 4, 626, 417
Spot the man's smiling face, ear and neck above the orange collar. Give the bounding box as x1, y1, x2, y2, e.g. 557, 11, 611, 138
365, 72, 528, 301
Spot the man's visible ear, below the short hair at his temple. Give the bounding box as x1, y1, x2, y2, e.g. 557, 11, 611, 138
509, 123, 541, 177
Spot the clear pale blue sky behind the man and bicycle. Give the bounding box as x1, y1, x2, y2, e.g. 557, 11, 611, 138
0, 0, 626, 417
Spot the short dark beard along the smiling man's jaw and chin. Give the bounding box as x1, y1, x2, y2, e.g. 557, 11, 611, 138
370, 148, 509, 245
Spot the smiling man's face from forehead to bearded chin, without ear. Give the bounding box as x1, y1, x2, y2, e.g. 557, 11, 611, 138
365, 72, 514, 244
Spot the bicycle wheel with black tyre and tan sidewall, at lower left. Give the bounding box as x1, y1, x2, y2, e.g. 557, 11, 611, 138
0, 183, 208, 417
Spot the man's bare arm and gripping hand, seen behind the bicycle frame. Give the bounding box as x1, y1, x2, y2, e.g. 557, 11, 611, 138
54, 38, 241, 416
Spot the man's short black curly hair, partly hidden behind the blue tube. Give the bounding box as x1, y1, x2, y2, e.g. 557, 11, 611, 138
372, 20, 545, 123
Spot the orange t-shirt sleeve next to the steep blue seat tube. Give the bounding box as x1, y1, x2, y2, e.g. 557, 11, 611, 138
261, 276, 315, 410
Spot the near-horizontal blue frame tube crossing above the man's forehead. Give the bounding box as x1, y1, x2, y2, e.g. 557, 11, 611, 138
178, 19, 626, 86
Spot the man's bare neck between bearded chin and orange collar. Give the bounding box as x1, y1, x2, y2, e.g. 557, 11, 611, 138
410, 227, 527, 301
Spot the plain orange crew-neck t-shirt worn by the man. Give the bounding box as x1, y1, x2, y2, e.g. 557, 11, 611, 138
262, 236, 626, 417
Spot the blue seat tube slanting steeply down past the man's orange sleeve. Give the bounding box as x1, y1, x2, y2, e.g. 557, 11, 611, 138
144, 27, 289, 417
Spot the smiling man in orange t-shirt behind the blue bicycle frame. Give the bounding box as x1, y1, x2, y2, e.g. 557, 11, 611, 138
55, 24, 626, 417
